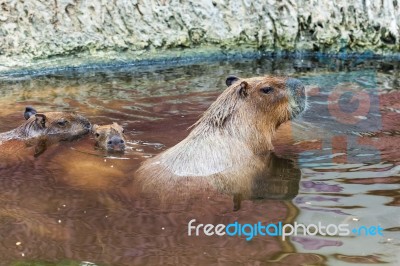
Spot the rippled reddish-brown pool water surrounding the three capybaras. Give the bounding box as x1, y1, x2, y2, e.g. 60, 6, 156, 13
0, 57, 400, 265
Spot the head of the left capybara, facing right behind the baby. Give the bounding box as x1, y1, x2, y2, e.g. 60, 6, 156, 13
18, 107, 91, 141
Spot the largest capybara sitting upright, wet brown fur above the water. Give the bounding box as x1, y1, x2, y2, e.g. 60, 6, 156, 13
136, 76, 306, 194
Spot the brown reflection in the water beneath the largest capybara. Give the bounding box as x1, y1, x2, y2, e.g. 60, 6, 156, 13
137, 152, 301, 211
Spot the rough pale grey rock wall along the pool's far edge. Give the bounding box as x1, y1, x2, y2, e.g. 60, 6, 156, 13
0, 0, 400, 70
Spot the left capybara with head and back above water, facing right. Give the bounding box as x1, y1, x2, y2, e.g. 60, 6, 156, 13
0, 107, 91, 155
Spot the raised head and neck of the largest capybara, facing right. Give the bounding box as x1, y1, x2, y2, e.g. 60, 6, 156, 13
190, 76, 306, 152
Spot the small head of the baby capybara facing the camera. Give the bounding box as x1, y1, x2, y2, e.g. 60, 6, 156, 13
92, 122, 126, 152
